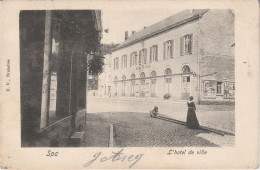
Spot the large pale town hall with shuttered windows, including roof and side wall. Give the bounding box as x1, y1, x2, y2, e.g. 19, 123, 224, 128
106, 9, 235, 101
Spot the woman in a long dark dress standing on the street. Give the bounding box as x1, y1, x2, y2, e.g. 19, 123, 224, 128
187, 96, 199, 129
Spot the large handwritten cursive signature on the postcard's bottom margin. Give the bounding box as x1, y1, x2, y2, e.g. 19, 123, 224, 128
84, 149, 144, 168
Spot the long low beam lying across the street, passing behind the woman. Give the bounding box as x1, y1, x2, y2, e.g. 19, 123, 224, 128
156, 115, 235, 136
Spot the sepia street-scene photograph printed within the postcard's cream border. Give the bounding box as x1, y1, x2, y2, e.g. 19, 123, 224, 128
19, 9, 236, 147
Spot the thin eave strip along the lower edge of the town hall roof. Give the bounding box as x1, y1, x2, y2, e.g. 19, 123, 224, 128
112, 12, 206, 52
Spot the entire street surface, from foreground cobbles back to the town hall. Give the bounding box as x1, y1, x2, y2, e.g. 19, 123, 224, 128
87, 97, 235, 147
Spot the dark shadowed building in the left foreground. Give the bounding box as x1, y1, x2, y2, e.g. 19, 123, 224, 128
19, 10, 102, 143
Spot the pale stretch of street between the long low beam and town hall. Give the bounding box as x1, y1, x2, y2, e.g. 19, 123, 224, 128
87, 95, 235, 133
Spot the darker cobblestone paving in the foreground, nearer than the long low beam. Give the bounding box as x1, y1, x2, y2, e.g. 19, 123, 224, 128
87, 112, 234, 147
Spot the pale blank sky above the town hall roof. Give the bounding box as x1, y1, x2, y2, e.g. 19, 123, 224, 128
101, 9, 180, 44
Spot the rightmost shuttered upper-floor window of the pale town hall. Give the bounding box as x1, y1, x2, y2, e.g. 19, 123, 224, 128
180, 34, 192, 55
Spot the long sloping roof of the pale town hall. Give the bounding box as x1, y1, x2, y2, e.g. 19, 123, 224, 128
114, 9, 208, 51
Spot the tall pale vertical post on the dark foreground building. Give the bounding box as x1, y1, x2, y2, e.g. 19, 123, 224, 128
40, 11, 52, 129
